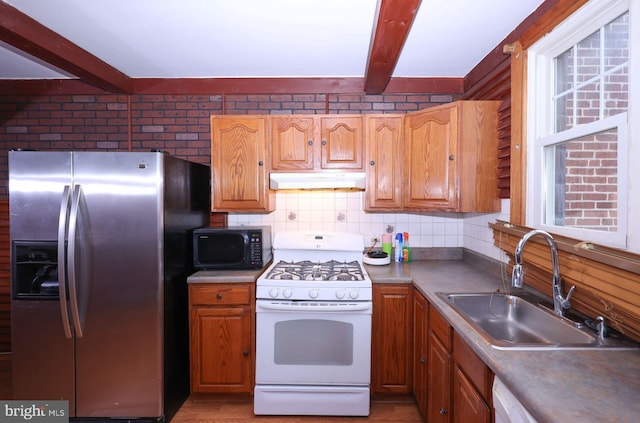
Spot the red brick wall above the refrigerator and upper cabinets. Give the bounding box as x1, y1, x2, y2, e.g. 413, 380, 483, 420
0, 94, 459, 199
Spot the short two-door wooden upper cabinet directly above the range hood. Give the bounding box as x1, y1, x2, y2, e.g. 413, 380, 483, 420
271, 115, 364, 172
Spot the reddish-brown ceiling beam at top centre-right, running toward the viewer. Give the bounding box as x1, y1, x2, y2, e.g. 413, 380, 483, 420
364, 0, 421, 94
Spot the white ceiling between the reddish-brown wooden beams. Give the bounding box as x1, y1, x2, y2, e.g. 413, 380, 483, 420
0, 0, 543, 79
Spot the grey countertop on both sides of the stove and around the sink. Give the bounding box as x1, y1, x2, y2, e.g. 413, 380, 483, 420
188, 260, 640, 423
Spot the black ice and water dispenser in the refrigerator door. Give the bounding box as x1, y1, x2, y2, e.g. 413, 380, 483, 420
11, 241, 59, 299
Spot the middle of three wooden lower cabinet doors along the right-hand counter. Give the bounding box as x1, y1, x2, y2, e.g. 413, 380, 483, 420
427, 332, 451, 423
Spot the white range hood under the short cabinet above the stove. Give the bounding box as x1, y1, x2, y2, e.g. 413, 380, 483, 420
269, 172, 365, 190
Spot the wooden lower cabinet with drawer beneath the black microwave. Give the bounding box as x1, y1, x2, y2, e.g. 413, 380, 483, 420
189, 283, 255, 394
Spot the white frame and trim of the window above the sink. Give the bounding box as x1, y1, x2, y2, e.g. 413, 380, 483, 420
526, 0, 640, 252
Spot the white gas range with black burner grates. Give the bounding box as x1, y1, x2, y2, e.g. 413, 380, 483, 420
254, 232, 372, 416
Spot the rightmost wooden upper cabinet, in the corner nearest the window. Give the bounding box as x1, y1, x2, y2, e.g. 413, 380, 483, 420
404, 101, 500, 212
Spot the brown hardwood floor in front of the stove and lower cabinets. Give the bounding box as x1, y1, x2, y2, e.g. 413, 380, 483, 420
0, 354, 422, 423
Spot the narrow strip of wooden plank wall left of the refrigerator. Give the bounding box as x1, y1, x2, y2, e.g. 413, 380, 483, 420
0, 200, 11, 353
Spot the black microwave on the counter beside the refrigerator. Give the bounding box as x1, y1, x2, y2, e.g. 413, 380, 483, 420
193, 226, 273, 269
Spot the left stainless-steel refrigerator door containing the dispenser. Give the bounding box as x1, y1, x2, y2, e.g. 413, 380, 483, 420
9, 151, 75, 410
